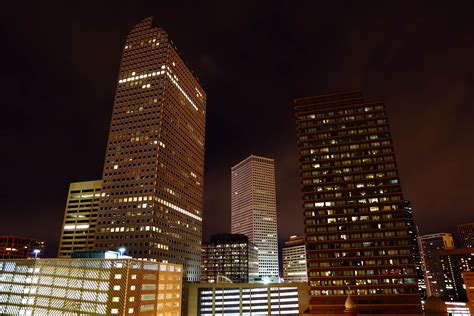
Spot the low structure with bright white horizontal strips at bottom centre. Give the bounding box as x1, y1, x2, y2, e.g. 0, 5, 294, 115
185, 283, 309, 316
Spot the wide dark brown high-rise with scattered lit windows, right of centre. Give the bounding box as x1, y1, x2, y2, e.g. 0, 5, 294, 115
295, 91, 421, 315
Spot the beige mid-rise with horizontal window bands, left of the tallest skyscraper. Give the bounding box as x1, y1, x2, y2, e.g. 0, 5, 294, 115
58, 180, 102, 258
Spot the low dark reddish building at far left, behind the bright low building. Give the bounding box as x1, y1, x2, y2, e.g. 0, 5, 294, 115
0, 235, 45, 260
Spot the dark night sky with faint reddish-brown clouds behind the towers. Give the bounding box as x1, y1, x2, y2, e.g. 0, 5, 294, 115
0, 1, 474, 256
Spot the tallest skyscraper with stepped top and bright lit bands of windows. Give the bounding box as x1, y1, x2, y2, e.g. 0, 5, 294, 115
95, 17, 206, 281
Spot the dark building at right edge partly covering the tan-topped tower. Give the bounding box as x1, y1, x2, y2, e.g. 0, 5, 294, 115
438, 247, 474, 302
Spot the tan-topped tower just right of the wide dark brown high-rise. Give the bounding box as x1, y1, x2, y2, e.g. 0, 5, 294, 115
418, 233, 454, 297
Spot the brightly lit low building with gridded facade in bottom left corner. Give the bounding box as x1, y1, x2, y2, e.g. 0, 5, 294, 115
0, 259, 183, 315
